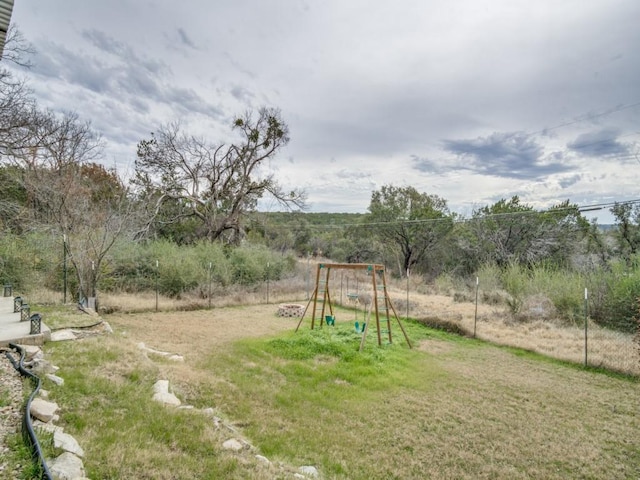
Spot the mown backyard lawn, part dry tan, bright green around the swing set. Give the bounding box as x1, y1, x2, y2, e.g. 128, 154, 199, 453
41, 305, 640, 479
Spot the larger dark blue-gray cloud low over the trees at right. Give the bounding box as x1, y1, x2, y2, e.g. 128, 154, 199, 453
440, 132, 570, 179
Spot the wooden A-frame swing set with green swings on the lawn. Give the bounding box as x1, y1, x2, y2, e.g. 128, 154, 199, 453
296, 263, 412, 351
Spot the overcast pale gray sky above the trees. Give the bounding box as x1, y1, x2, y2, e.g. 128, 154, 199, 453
6, 0, 640, 223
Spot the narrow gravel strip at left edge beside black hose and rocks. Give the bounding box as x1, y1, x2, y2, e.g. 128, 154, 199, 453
0, 348, 23, 478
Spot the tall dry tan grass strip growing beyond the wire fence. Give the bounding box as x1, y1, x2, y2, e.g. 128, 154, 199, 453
32, 264, 640, 375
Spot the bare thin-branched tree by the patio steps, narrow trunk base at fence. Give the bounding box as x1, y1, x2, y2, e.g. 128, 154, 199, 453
6, 112, 138, 297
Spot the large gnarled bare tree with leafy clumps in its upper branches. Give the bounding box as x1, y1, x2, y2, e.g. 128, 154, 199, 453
134, 108, 304, 242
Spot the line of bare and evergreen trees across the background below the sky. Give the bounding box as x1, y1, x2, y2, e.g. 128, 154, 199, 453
0, 26, 640, 334
